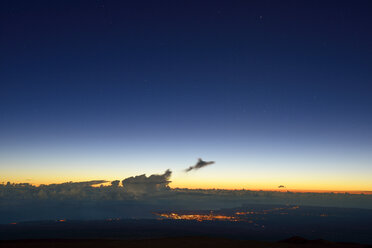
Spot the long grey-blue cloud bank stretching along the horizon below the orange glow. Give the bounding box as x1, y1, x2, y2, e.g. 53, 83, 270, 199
0, 170, 372, 223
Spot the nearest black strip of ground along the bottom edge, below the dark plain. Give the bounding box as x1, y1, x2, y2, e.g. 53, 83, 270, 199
0, 237, 371, 248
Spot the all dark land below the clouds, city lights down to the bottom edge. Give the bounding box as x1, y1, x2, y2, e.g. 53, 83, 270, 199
0, 205, 372, 245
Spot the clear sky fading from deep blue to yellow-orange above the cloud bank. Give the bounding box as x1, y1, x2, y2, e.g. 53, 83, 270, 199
0, 0, 372, 190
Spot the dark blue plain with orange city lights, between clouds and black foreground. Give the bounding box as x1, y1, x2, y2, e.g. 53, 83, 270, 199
0, 204, 372, 244
